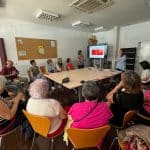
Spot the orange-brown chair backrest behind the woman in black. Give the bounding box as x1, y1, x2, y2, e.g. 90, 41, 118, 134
122, 110, 136, 128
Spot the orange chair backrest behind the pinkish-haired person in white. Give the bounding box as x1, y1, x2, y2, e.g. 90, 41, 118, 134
22, 110, 51, 137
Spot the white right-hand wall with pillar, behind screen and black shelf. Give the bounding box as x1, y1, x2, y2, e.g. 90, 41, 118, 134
94, 21, 150, 72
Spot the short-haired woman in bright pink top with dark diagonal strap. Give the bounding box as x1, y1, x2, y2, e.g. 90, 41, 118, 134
69, 81, 112, 129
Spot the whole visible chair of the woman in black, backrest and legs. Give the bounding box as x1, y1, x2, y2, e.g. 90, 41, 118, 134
111, 110, 137, 150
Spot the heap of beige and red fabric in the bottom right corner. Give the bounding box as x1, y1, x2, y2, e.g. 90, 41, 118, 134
118, 124, 150, 150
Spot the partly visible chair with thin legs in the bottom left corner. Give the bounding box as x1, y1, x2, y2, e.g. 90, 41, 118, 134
0, 126, 20, 150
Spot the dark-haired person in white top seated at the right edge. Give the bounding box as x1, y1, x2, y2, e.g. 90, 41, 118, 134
140, 61, 150, 85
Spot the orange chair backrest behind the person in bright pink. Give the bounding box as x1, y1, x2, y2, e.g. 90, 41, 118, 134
67, 125, 110, 148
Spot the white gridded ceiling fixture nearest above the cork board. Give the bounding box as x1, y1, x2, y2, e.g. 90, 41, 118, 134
35, 9, 60, 21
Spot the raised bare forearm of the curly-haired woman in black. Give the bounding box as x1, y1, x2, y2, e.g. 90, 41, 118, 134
106, 81, 123, 103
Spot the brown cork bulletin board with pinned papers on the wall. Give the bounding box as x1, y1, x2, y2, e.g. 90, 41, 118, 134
15, 37, 57, 60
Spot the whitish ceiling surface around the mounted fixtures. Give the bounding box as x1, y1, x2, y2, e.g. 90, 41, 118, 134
0, 0, 150, 32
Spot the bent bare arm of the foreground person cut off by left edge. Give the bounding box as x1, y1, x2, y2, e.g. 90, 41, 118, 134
0, 93, 23, 120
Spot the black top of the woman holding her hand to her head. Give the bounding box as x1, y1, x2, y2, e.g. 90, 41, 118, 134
111, 91, 144, 126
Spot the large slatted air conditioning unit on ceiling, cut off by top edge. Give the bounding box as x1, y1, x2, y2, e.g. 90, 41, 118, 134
70, 0, 115, 13
